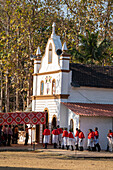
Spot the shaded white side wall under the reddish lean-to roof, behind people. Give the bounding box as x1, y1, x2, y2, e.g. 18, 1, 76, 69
80, 116, 113, 150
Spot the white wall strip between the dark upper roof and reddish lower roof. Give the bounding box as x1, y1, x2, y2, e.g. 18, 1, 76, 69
68, 86, 113, 104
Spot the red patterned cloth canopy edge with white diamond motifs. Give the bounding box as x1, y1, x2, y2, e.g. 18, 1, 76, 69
0, 112, 46, 125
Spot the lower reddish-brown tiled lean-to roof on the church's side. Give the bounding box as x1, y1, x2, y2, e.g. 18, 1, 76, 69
63, 102, 113, 117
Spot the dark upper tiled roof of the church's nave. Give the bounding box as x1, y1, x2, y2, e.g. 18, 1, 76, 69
70, 63, 113, 88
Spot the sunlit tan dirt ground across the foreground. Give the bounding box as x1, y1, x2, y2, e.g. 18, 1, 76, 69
0, 151, 113, 170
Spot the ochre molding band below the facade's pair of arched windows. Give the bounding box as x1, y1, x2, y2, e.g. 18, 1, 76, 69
32, 94, 70, 100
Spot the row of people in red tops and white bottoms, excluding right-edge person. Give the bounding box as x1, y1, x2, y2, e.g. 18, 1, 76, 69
43, 126, 101, 152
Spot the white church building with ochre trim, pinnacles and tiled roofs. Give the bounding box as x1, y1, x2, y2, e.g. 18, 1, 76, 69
32, 23, 113, 149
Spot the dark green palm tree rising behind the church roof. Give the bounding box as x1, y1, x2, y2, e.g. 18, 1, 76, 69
72, 30, 111, 65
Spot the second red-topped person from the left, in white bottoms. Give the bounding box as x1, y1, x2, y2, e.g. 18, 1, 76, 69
52, 127, 58, 148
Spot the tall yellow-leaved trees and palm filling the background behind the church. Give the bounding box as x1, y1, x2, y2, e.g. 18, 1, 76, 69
0, 0, 113, 111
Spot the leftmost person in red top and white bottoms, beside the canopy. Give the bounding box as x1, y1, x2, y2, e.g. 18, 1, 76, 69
43, 126, 50, 149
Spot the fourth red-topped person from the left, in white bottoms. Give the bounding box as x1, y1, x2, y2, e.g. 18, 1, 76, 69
62, 128, 69, 150
